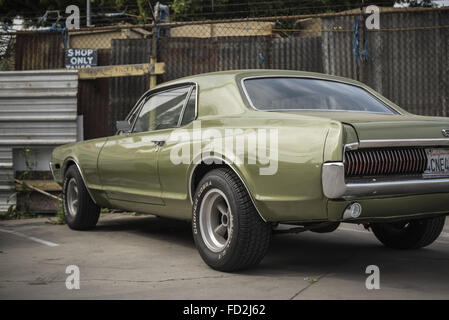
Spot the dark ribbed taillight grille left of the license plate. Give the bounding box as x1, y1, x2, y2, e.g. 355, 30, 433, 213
345, 148, 427, 177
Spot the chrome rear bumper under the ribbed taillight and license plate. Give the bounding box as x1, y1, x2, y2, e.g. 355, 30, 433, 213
322, 162, 449, 199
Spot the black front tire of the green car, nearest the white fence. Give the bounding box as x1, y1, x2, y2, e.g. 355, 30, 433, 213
62, 165, 100, 230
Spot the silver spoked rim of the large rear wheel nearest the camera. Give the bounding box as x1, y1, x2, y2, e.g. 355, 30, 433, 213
199, 189, 232, 252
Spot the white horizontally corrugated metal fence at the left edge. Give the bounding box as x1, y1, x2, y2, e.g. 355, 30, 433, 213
0, 70, 78, 211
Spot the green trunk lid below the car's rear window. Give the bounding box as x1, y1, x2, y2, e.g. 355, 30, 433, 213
286, 111, 449, 140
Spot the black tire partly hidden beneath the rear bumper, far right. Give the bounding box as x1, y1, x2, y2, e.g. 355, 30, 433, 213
371, 216, 446, 250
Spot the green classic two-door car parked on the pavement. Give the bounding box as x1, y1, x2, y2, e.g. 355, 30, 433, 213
50, 70, 449, 271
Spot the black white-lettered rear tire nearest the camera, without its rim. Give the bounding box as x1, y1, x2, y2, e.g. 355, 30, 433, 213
192, 168, 271, 272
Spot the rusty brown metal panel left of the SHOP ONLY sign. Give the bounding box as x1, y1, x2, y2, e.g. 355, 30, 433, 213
15, 32, 64, 70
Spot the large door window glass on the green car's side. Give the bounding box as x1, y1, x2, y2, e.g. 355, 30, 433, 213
133, 87, 190, 132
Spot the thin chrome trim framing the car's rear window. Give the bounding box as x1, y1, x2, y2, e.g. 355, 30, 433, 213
240, 75, 403, 115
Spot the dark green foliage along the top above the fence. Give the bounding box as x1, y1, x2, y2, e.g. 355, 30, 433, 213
0, 0, 416, 25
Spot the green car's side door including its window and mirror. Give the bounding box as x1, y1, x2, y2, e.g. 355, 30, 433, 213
98, 85, 191, 205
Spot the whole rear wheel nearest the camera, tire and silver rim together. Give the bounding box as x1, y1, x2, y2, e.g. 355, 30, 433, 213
192, 168, 271, 271
